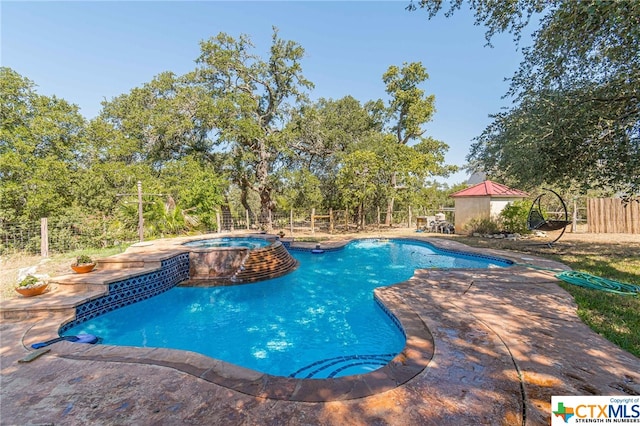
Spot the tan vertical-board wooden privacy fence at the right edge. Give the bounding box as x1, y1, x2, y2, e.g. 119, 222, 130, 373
587, 198, 640, 234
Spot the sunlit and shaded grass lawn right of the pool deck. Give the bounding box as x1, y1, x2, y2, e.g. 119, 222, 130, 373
454, 234, 640, 358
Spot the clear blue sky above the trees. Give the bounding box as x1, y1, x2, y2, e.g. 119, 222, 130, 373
0, 0, 526, 184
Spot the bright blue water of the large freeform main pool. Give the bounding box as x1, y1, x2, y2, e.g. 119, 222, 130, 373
65, 240, 509, 378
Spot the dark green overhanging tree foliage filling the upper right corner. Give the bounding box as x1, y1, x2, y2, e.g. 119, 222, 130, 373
409, 0, 640, 194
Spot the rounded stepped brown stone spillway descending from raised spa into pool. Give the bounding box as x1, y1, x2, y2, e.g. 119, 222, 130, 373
233, 241, 298, 282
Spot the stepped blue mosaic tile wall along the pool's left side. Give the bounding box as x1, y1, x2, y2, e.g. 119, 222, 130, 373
60, 253, 189, 334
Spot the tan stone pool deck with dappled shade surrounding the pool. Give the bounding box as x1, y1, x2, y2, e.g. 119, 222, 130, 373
0, 238, 640, 426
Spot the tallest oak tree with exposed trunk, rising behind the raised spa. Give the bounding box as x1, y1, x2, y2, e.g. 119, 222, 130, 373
194, 28, 313, 230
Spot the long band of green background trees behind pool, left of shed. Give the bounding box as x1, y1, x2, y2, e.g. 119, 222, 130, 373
0, 29, 453, 238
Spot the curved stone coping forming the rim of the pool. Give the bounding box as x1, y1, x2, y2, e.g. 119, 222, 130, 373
5, 233, 568, 402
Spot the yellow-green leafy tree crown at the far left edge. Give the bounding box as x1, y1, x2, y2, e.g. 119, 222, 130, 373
0, 67, 84, 221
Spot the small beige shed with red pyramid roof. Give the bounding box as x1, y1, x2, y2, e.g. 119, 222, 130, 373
450, 180, 529, 232
